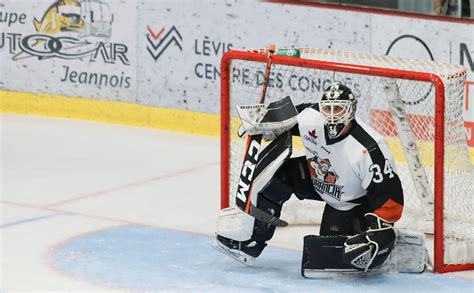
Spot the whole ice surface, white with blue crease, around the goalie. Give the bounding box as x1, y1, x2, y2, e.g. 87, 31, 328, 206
0, 114, 474, 292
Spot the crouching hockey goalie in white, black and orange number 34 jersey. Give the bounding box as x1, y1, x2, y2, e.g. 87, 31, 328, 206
214, 83, 427, 278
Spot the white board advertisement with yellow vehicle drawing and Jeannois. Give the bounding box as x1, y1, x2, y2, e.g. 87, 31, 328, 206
0, 0, 137, 102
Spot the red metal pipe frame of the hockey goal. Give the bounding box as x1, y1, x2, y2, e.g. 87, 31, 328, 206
220, 50, 474, 273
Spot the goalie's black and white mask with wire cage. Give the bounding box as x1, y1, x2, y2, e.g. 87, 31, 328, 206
319, 82, 357, 139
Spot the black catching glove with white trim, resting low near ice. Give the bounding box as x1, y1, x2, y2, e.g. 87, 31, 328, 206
342, 213, 397, 272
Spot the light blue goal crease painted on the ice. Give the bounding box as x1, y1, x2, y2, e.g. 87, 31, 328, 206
52, 226, 474, 292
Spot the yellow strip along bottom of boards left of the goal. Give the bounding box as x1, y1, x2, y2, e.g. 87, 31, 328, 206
0, 91, 220, 136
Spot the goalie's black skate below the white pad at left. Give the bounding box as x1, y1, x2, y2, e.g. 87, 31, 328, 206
213, 235, 267, 267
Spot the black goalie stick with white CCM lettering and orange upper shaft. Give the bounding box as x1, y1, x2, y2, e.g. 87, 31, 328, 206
236, 45, 288, 227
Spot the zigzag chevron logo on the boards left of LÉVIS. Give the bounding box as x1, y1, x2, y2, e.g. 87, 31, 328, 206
146, 25, 183, 61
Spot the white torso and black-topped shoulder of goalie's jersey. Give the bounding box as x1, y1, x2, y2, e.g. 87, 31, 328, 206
297, 107, 396, 211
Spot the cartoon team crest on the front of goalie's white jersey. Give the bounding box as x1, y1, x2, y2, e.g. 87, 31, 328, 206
308, 152, 344, 200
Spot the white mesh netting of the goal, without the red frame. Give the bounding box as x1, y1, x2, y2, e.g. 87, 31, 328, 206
223, 49, 474, 264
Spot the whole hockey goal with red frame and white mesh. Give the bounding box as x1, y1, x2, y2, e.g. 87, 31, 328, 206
221, 49, 474, 272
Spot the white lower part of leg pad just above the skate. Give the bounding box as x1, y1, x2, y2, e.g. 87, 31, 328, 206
217, 207, 255, 241
